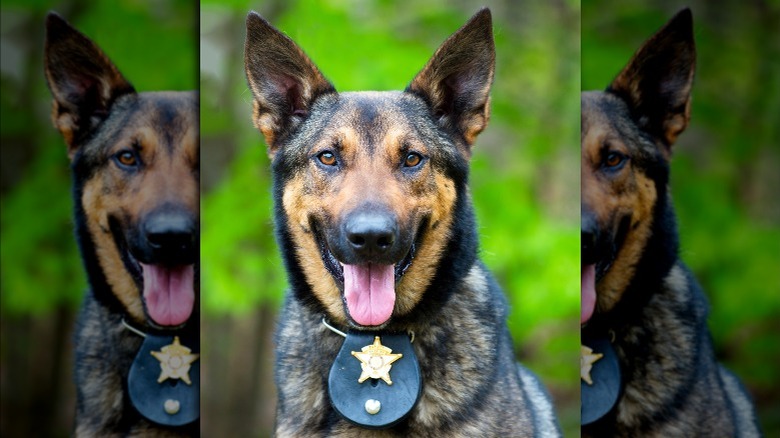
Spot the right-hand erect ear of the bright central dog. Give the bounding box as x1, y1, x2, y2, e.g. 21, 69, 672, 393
406, 8, 496, 152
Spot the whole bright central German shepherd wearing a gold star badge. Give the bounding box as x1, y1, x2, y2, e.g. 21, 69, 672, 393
245, 9, 559, 437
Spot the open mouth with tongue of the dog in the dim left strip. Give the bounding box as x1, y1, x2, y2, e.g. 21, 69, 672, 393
111, 219, 195, 329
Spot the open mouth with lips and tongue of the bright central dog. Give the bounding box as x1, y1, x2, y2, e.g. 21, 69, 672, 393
314, 227, 424, 327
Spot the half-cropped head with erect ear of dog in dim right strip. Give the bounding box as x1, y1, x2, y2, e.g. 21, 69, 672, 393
581, 9, 695, 323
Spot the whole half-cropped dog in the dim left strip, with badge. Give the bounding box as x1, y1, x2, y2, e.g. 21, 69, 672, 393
44, 13, 200, 436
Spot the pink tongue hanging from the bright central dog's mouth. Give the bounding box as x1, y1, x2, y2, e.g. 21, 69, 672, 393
344, 264, 395, 325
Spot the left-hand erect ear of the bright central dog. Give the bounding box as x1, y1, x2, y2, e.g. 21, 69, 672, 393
244, 12, 336, 157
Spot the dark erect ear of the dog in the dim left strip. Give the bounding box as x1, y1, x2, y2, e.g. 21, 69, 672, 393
44, 12, 135, 158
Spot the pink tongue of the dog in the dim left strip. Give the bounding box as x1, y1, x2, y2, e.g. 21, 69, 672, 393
141, 263, 195, 326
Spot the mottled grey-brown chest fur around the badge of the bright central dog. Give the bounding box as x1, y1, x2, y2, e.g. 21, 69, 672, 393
276, 266, 532, 437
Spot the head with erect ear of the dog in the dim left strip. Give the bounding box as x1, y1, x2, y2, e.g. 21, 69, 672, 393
45, 14, 199, 328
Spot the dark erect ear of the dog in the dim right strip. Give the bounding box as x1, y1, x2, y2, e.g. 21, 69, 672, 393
607, 9, 696, 152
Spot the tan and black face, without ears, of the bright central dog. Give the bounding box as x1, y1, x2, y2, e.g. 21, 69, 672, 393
274, 93, 464, 326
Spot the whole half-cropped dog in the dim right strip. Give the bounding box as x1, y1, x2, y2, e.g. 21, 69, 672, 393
581, 9, 759, 437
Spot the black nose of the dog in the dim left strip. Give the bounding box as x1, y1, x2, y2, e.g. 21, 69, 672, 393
142, 209, 197, 265
